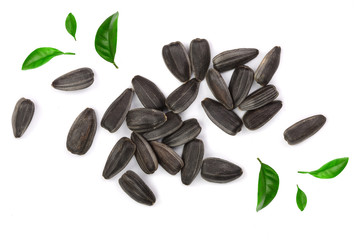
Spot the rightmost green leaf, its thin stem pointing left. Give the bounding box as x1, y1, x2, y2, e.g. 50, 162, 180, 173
298, 157, 349, 179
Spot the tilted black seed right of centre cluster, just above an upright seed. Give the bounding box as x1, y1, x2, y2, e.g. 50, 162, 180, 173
162, 118, 201, 147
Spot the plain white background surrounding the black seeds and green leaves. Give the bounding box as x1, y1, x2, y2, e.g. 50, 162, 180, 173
0, 0, 360, 240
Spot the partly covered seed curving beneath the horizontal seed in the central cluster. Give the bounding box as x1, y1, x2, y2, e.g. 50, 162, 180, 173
143, 112, 183, 141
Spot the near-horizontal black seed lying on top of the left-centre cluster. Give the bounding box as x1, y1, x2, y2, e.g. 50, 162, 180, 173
126, 108, 166, 132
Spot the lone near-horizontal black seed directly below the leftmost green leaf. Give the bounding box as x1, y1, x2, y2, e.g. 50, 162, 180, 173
51, 68, 94, 91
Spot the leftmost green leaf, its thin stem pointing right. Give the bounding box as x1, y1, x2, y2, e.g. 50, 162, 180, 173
21, 47, 75, 70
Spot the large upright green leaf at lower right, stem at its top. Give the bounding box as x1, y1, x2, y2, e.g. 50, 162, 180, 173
256, 158, 279, 211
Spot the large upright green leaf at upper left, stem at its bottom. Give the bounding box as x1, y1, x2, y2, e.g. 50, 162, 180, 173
95, 12, 119, 68
